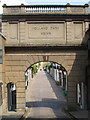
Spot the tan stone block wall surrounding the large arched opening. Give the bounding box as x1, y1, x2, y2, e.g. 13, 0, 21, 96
5, 47, 87, 110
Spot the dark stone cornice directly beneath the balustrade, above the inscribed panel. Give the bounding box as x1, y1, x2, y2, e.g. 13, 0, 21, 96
2, 14, 90, 22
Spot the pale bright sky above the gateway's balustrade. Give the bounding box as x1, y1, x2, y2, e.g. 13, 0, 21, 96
0, 0, 90, 13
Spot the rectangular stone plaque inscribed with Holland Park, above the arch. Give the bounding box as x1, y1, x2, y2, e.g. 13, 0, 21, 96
28, 23, 65, 39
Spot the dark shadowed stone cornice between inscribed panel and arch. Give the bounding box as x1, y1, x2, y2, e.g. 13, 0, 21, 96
5, 46, 88, 53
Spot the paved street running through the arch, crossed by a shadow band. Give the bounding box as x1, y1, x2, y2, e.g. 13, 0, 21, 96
25, 70, 68, 118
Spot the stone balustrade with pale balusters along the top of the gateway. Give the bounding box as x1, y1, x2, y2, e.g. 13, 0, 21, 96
3, 4, 88, 14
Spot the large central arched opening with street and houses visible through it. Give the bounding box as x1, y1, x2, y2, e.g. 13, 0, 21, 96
25, 62, 67, 117
